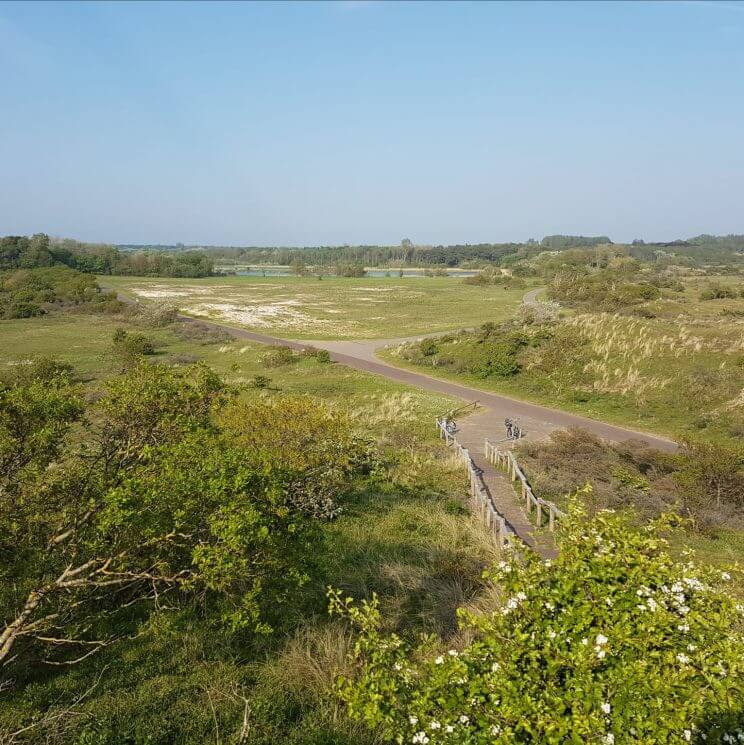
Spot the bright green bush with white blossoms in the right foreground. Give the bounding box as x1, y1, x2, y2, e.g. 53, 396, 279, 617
330, 496, 744, 745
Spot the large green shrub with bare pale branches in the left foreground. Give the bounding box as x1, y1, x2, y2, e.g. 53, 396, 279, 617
0, 361, 376, 684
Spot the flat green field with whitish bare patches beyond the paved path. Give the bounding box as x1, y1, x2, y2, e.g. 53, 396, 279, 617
100, 277, 531, 339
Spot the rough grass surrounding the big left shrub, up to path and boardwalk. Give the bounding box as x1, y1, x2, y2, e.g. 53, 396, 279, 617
0, 309, 502, 745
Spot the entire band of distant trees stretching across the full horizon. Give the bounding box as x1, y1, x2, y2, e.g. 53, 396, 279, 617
0, 233, 744, 277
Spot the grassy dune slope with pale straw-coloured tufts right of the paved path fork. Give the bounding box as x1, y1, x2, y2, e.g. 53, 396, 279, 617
380, 300, 744, 439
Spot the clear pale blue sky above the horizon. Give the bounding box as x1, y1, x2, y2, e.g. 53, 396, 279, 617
0, 2, 744, 245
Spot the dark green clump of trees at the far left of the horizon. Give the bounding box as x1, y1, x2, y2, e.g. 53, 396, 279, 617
0, 233, 214, 277
